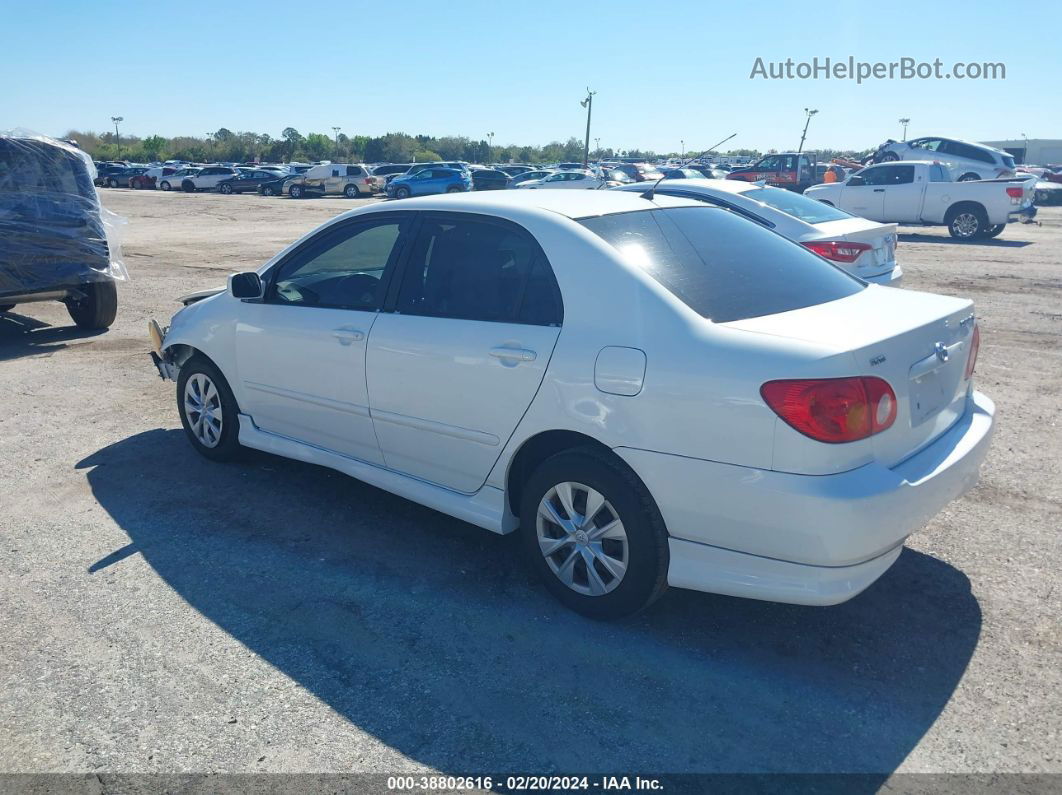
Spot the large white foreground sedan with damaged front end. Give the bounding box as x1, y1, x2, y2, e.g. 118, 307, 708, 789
152, 191, 994, 618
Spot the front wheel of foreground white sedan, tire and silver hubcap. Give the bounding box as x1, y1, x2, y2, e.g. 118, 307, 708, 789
177, 355, 242, 461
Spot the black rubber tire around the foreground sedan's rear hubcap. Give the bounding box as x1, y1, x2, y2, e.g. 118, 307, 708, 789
519, 447, 669, 620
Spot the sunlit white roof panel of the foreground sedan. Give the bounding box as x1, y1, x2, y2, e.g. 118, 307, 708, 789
356, 185, 704, 220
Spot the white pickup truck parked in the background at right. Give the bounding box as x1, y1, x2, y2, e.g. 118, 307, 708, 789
804, 160, 1037, 240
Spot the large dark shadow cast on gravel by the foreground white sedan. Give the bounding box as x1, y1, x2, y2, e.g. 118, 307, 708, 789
78, 430, 981, 776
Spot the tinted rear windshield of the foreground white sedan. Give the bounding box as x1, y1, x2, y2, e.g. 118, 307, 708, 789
579, 207, 866, 323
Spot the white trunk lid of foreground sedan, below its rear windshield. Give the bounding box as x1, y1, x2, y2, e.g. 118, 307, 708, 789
726, 286, 974, 467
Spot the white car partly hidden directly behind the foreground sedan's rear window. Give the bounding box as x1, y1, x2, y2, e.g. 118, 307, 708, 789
613, 179, 904, 287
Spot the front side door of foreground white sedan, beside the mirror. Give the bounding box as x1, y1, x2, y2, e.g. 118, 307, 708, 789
236, 212, 414, 464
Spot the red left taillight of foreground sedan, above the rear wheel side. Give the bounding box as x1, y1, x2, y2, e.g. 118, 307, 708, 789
759, 376, 896, 444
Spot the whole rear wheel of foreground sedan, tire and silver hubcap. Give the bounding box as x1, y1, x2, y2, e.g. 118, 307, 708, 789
520, 448, 668, 619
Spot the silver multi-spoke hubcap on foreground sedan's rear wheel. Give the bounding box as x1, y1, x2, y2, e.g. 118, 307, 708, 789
536, 482, 629, 597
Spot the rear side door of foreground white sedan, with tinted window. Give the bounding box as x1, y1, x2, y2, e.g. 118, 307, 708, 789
366, 212, 562, 494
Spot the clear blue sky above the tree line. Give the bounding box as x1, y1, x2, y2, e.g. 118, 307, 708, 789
0, 0, 1062, 152
